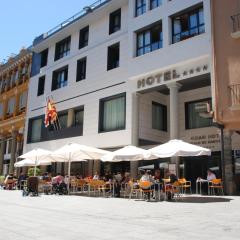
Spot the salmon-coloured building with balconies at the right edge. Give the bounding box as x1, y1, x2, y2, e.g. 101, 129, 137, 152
211, 0, 240, 192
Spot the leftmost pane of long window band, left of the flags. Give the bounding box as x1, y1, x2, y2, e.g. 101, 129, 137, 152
28, 118, 42, 143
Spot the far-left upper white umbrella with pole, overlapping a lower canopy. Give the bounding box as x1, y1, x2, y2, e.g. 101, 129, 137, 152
18, 148, 52, 176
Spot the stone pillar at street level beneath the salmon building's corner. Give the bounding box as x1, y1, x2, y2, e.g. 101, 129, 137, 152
223, 131, 236, 195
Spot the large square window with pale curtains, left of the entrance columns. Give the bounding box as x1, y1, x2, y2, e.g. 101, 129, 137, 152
99, 93, 126, 132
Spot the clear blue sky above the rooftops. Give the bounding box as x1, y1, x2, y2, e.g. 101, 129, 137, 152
0, 0, 96, 62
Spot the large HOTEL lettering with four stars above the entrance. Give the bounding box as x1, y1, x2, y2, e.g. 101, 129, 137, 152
137, 64, 209, 89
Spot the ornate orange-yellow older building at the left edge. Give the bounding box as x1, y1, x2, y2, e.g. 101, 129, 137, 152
0, 49, 32, 175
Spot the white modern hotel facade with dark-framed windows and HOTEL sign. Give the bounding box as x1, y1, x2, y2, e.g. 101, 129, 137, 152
24, 0, 240, 193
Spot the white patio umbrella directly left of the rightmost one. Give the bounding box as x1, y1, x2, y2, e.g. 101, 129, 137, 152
101, 146, 150, 162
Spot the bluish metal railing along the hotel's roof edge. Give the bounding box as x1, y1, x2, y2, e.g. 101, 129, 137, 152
43, 0, 111, 38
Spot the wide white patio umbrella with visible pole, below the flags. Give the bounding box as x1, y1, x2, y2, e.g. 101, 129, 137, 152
50, 143, 109, 191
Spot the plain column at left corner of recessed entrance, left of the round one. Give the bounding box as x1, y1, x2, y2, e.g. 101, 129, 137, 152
130, 93, 139, 179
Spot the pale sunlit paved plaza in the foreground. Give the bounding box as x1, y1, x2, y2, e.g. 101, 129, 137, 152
0, 190, 240, 240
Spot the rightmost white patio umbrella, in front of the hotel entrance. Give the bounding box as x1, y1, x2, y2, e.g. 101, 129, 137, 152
148, 139, 211, 159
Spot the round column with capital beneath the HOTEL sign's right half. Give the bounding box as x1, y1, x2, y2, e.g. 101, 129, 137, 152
167, 82, 181, 176
